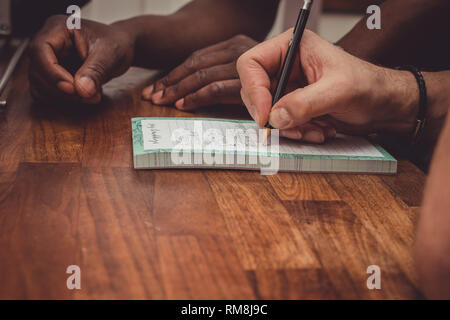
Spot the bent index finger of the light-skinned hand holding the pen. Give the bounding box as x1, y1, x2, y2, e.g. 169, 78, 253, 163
237, 30, 292, 127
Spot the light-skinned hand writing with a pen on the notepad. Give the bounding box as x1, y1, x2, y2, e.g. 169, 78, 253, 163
237, 30, 418, 143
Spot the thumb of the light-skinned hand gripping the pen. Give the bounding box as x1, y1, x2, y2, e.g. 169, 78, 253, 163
269, 79, 339, 129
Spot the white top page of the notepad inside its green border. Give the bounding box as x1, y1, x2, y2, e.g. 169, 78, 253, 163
142, 118, 383, 158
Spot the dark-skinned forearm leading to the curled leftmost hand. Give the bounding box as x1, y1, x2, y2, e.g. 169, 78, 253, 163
116, 0, 278, 69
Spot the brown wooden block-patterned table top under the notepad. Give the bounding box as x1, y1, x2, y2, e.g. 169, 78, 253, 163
0, 55, 425, 299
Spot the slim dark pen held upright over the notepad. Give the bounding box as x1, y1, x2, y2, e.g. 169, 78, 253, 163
263, 0, 313, 144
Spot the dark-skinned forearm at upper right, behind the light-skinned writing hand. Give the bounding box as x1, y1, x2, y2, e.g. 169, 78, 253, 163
339, 0, 450, 69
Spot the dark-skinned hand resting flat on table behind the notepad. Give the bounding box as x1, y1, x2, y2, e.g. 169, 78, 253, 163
142, 35, 257, 110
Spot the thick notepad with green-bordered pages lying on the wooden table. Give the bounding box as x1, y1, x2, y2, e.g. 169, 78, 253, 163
132, 118, 397, 174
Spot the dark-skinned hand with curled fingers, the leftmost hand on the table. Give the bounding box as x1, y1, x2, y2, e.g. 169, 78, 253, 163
29, 16, 134, 104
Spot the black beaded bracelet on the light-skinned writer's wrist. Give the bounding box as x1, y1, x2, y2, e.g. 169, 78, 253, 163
397, 66, 428, 144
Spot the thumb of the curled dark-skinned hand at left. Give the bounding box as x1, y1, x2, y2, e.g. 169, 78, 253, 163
75, 50, 114, 99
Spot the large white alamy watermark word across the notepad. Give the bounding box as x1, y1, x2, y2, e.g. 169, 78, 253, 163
155, 121, 280, 175
